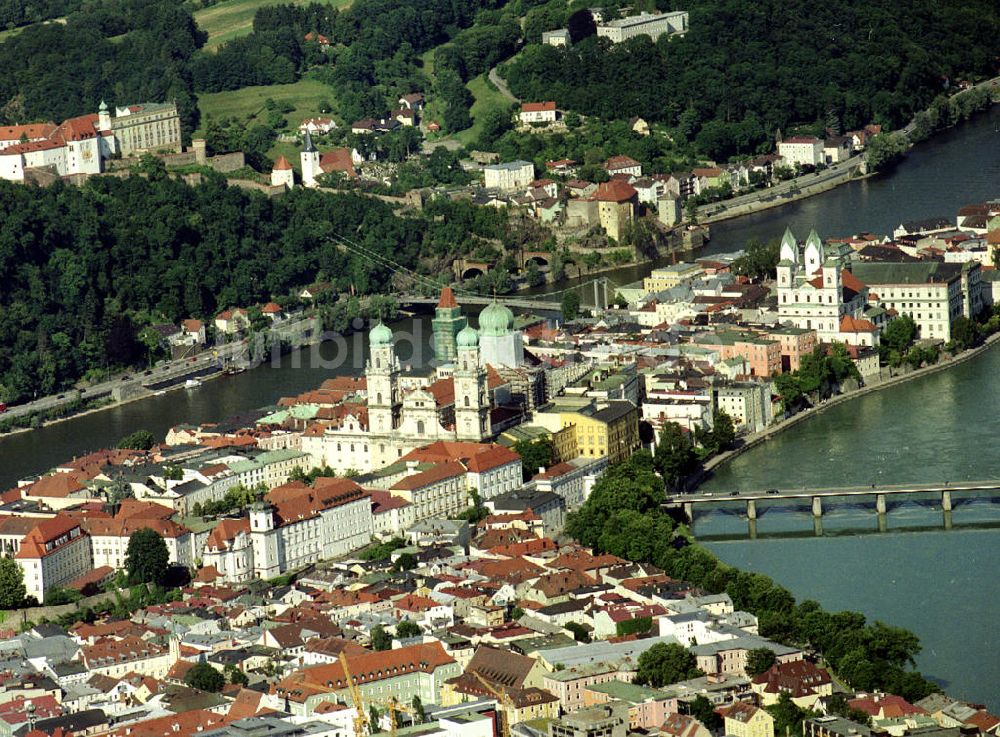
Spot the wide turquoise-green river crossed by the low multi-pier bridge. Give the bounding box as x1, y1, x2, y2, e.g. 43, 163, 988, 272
694, 347, 1000, 712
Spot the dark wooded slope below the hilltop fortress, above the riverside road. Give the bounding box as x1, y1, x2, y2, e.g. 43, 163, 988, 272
0, 176, 505, 402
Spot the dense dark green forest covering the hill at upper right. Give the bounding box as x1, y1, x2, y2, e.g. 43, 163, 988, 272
506, 0, 1000, 158
